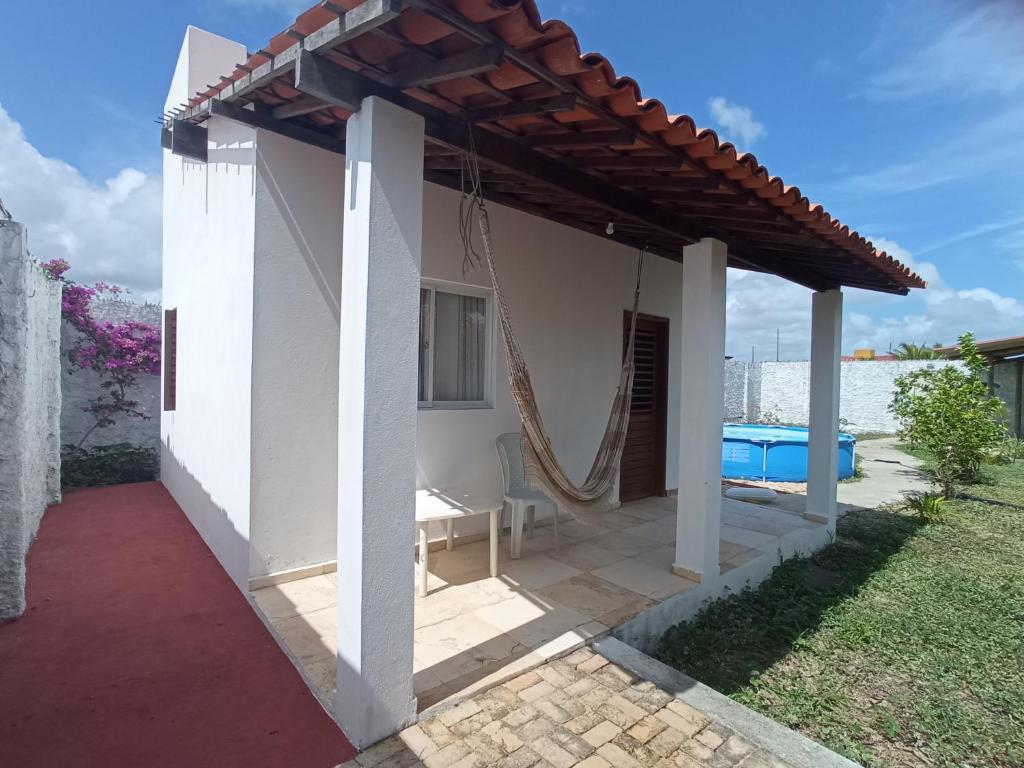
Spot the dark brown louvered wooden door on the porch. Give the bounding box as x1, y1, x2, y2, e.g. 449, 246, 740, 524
618, 312, 669, 502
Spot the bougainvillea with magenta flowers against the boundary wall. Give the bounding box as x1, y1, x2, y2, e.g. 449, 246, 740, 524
42, 259, 160, 449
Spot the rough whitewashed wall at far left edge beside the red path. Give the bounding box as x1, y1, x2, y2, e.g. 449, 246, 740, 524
0, 220, 60, 621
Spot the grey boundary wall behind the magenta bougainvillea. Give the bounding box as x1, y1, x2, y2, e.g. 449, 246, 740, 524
60, 300, 162, 449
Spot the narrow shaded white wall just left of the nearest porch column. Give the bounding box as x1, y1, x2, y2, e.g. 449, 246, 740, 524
250, 131, 345, 577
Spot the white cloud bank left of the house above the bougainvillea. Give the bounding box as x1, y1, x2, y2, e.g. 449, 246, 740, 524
0, 105, 162, 299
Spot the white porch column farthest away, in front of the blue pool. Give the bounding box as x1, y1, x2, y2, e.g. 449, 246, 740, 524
804, 290, 843, 530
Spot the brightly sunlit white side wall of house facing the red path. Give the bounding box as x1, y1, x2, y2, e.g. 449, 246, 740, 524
160, 28, 256, 589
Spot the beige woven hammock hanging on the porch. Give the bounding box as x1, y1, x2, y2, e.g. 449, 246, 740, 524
460, 143, 643, 522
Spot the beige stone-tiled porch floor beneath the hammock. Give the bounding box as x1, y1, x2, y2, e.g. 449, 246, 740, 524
252, 497, 825, 713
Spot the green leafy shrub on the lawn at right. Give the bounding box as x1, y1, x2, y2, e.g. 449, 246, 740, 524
889, 333, 1006, 498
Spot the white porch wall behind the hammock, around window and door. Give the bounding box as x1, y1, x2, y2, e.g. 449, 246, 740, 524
418, 184, 682, 512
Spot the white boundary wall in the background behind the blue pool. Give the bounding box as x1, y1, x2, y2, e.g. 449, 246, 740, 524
725, 360, 959, 434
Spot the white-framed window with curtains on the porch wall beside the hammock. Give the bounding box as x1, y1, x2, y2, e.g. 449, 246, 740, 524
419, 285, 492, 408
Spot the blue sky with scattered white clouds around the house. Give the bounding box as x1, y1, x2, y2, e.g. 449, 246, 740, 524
0, 0, 1024, 358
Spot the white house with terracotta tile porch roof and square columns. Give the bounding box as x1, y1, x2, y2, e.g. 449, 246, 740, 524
161, 0, 924, 745
